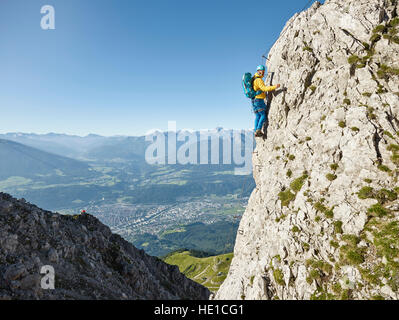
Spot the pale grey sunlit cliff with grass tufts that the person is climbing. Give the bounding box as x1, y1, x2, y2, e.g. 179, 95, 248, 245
216, 0, 399, 299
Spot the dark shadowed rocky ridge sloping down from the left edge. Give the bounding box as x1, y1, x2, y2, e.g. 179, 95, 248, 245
0, 193, 210, 300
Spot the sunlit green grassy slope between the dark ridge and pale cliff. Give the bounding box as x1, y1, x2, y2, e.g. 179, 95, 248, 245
164, 251, 233, 292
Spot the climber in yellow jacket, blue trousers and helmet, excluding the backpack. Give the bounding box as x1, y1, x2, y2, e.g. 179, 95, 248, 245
252, 65, 280, 137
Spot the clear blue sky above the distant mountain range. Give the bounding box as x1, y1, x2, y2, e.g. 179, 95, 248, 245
0, 0, 324, 135
